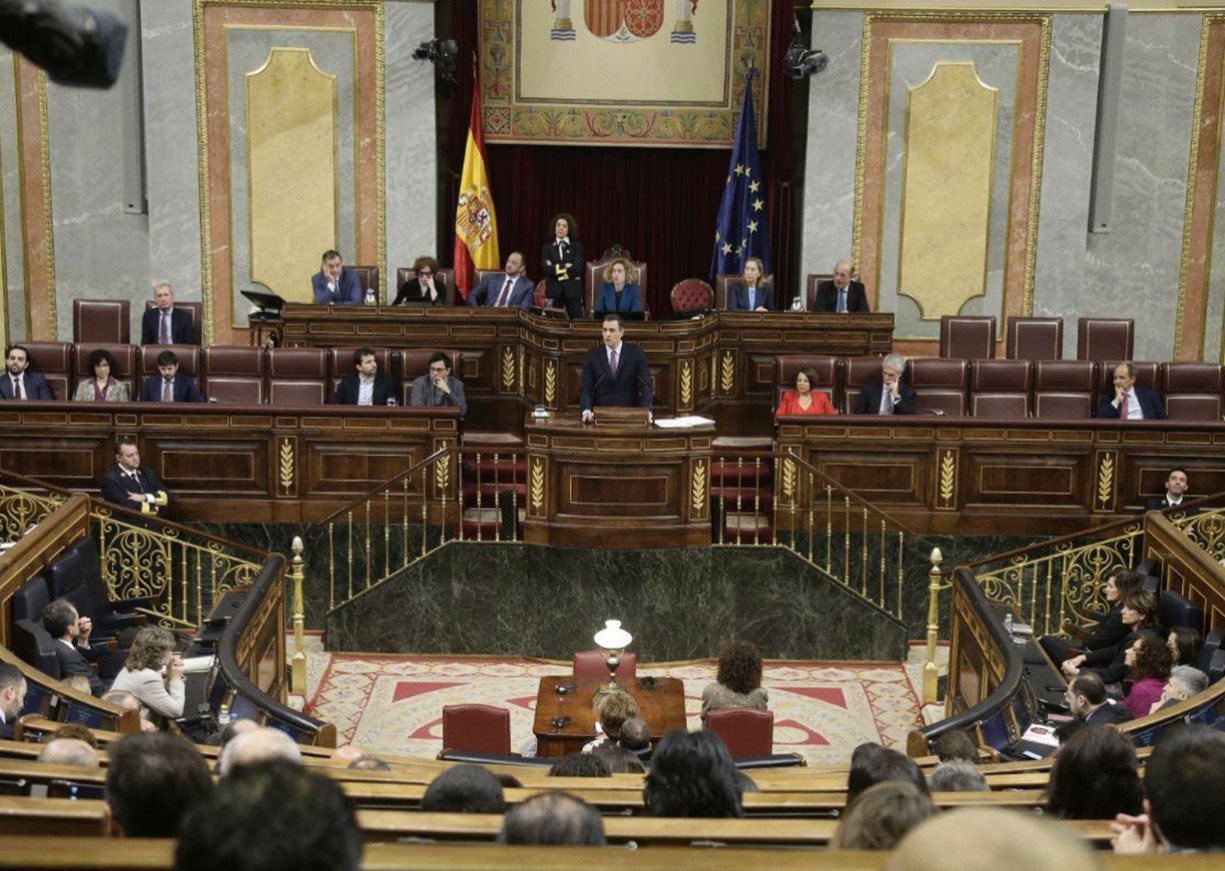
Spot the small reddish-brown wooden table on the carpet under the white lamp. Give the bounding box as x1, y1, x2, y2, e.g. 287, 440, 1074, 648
532, 675, 685, 757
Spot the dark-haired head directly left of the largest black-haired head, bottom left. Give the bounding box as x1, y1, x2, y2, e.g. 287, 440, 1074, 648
107, 733, 213, 838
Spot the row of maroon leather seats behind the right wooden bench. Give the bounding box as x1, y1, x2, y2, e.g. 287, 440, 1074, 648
775, 354, 1225, 420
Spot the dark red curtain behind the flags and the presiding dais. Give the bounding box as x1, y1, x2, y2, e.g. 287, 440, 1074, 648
448, 2, 795, 316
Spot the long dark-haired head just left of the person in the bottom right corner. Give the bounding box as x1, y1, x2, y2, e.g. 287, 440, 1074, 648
1046, 726, 1140, 820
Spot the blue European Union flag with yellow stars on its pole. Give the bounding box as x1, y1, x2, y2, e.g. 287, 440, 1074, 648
711, 70, 771, 281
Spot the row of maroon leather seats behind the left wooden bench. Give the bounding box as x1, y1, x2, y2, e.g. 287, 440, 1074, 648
15, 342, 459, 405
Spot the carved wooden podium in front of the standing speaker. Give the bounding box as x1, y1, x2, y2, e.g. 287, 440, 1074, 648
523, 409, 714, 550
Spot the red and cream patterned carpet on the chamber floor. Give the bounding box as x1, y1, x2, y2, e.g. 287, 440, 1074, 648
306, 641, 944, 764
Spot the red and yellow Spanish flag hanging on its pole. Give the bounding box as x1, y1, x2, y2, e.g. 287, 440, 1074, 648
454, 69, 502, 299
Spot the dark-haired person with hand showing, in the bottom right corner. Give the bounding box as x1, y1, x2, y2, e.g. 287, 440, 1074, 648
1111, 725, 1225, 853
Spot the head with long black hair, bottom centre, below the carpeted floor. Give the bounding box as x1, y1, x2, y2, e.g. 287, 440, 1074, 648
642, 729, 742, 817
